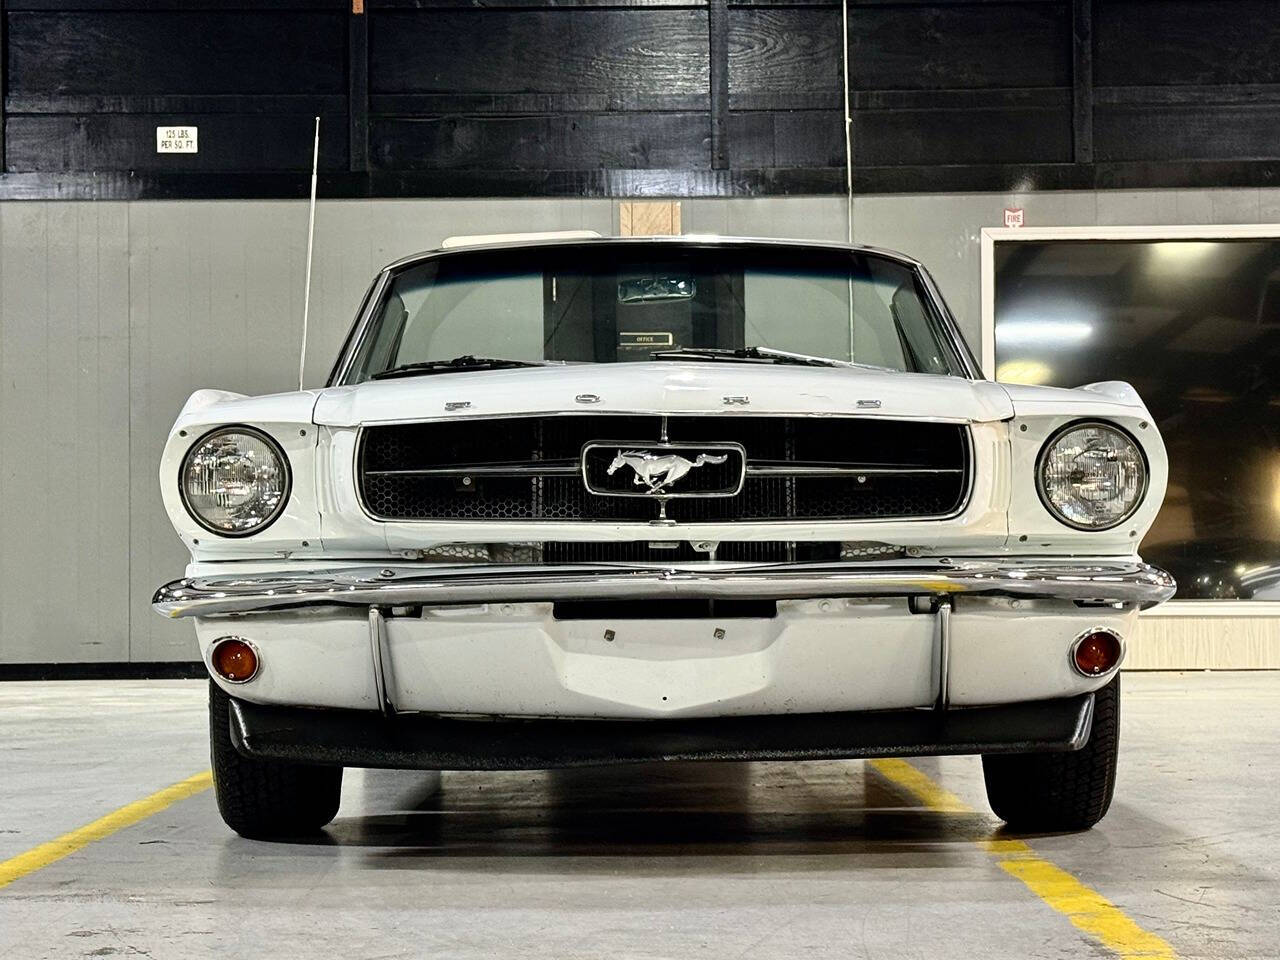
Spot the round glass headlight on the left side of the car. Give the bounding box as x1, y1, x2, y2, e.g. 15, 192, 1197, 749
178, 426, 289, 536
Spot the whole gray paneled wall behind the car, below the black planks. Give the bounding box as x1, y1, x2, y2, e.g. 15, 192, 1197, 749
0, 189, 1280, 662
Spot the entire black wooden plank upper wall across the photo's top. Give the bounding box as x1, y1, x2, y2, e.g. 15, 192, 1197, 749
0, 0, 1280, 197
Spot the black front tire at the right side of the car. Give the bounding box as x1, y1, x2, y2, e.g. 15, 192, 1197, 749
982, 675, 1120, 832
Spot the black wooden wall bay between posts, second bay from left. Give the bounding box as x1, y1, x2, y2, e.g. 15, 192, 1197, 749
369, 6, 710, 173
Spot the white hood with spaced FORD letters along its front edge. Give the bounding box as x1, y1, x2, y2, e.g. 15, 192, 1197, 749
315, 361, 1014, 426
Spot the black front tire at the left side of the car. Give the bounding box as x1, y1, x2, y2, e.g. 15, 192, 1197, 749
209, 680, 342, 840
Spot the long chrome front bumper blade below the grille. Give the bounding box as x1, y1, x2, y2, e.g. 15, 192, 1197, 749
151, 559, 1176, 617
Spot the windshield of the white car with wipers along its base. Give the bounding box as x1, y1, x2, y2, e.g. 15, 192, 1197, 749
344, 242, 964, 383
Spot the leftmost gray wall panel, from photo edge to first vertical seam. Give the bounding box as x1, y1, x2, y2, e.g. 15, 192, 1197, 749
0, 204, 129, 660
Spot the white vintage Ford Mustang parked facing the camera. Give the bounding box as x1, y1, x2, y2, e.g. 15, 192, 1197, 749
154, 237, 1174, 837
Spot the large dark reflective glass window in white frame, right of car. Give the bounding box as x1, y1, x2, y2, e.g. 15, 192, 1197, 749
995, 239, 1280, 600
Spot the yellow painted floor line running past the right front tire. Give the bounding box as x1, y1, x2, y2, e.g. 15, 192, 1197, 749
870, 760, 1178, 960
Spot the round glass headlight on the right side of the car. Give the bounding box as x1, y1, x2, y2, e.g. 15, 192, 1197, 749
1036, 422, 1147, 530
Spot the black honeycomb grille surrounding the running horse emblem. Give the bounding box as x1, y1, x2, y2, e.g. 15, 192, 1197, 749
357, 415, 970, 522
